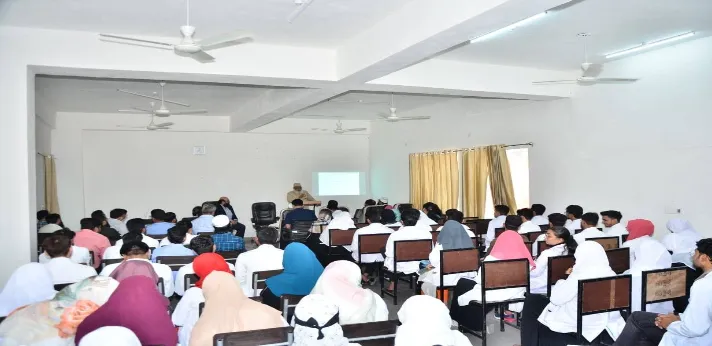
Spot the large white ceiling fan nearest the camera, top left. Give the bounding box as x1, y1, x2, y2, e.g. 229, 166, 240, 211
99, 0, 252, 63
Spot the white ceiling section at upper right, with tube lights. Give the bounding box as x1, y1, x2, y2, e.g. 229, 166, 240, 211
440, 0, 712, 70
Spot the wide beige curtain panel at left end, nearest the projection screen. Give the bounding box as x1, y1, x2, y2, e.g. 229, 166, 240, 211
410, 152, 460, 210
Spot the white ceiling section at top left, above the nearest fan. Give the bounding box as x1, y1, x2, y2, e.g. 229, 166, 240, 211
0, 0, 411, 48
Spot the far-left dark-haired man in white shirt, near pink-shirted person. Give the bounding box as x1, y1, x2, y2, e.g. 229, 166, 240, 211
42, 235, 96, 285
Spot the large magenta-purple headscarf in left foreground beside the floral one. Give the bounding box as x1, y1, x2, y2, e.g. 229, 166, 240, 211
76, 276, 178, 345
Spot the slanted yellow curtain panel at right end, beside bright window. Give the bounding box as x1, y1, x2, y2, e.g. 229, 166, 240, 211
486, 145, 517, 211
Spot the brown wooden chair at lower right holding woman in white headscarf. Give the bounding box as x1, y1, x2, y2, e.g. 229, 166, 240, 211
576, 275, 632, 345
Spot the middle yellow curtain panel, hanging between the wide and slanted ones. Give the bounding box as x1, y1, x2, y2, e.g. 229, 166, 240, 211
462, 148, 489, 218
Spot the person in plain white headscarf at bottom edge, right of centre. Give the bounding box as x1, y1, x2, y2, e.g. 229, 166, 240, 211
395, 296, 472, 346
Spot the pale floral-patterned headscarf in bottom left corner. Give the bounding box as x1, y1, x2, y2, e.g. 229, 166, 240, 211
0, 276, 119, 346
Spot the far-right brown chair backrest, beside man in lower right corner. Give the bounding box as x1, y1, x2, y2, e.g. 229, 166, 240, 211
640, 267, 689, 311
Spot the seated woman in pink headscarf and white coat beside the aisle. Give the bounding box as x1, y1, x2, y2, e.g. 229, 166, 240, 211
450, 227, 536, 332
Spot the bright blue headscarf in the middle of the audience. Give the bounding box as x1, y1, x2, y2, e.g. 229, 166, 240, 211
266, 243, 324, 297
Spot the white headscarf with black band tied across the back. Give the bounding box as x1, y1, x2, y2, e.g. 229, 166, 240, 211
293, 294, 349, 346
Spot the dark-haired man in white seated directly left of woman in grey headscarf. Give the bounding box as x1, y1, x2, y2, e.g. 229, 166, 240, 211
383, 209, 433, 291
